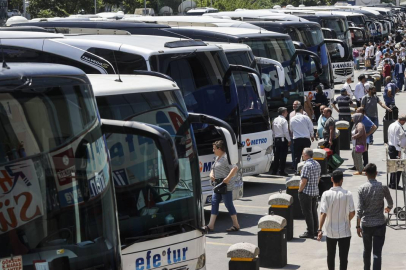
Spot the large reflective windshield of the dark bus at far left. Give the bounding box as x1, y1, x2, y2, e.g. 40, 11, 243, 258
0, 80, 120, 269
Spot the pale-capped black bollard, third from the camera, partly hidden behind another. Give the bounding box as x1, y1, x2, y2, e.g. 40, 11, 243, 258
268, 191, 294, 241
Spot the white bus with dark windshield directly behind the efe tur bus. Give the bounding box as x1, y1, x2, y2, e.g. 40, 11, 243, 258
0, 32, 261, 204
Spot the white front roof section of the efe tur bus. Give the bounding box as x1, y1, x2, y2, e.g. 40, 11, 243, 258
87, 74, 179, 97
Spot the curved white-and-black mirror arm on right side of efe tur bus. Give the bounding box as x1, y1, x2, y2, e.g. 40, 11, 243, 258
187, 113, 238, 164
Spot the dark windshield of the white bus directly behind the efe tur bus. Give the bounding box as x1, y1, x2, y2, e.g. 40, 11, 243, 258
150, 50, 240, 156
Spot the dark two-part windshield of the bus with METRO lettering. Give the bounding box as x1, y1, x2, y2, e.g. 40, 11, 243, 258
226, 51, 270, 134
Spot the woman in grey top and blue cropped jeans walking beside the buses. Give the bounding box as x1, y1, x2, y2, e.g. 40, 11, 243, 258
206, 141, 240, 232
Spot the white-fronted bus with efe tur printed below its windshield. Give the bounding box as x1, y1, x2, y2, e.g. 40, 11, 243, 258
88, 72, 238, 270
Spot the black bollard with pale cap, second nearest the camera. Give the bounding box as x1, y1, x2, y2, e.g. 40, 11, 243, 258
258, 215, 288, 268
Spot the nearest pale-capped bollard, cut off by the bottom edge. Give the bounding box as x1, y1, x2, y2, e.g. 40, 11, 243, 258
227, 243, 259, 270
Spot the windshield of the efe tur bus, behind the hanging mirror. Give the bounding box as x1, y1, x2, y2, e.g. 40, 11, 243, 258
97, 90, 202, 247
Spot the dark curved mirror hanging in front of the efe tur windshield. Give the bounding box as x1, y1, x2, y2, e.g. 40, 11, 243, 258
101, 119, 180, 192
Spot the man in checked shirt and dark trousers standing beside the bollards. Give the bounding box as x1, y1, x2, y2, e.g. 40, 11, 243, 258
298, 148, 321, 239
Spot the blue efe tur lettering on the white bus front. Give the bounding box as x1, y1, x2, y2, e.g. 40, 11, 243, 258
135, 247, 188, 270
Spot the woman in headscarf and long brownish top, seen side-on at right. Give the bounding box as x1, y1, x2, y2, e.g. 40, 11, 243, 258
351, 113, 367, 175
